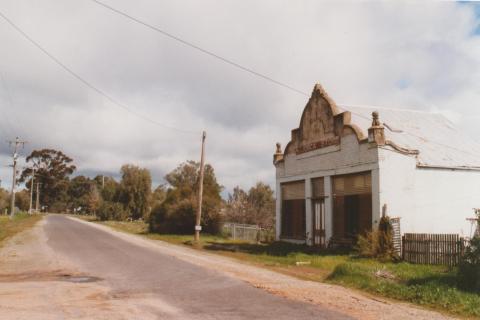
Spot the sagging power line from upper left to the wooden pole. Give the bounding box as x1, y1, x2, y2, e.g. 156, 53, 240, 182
0, 11, 200, 134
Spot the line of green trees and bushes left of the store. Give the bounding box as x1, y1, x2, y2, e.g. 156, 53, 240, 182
0, 149, 275, 234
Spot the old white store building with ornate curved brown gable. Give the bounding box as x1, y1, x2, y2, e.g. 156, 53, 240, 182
274, 85, 480, 246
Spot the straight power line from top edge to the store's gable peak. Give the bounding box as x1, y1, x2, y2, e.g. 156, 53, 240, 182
91, 0, 308, 96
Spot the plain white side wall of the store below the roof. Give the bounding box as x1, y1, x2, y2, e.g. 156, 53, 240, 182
379, 149, 480, 236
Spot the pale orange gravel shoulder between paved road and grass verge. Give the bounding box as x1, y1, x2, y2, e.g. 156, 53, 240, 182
71, 218, 453, 320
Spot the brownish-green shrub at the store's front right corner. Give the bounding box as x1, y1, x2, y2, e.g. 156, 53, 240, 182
355, 216, 399, 260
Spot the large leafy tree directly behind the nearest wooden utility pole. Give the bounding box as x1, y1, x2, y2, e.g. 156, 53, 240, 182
149, 161, 222, 234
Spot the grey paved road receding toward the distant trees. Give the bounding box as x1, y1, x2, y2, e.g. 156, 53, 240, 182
45, 215, 349, 320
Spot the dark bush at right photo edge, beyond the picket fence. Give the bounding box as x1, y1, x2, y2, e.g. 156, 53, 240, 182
458, 236, 480, 292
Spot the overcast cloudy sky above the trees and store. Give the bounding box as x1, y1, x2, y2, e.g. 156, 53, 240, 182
0, 0, 480, 191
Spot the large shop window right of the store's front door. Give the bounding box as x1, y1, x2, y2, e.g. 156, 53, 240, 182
333, 172, 372, 239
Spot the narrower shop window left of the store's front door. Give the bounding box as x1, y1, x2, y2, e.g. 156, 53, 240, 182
282, 181, 305, 239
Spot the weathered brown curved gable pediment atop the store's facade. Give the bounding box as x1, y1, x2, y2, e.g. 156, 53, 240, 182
285, 84, 365, 154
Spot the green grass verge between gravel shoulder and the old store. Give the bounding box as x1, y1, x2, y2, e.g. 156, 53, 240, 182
83, 221, 480, 318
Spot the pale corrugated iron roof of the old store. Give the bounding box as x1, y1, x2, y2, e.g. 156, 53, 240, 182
338, 105, 480, 169
